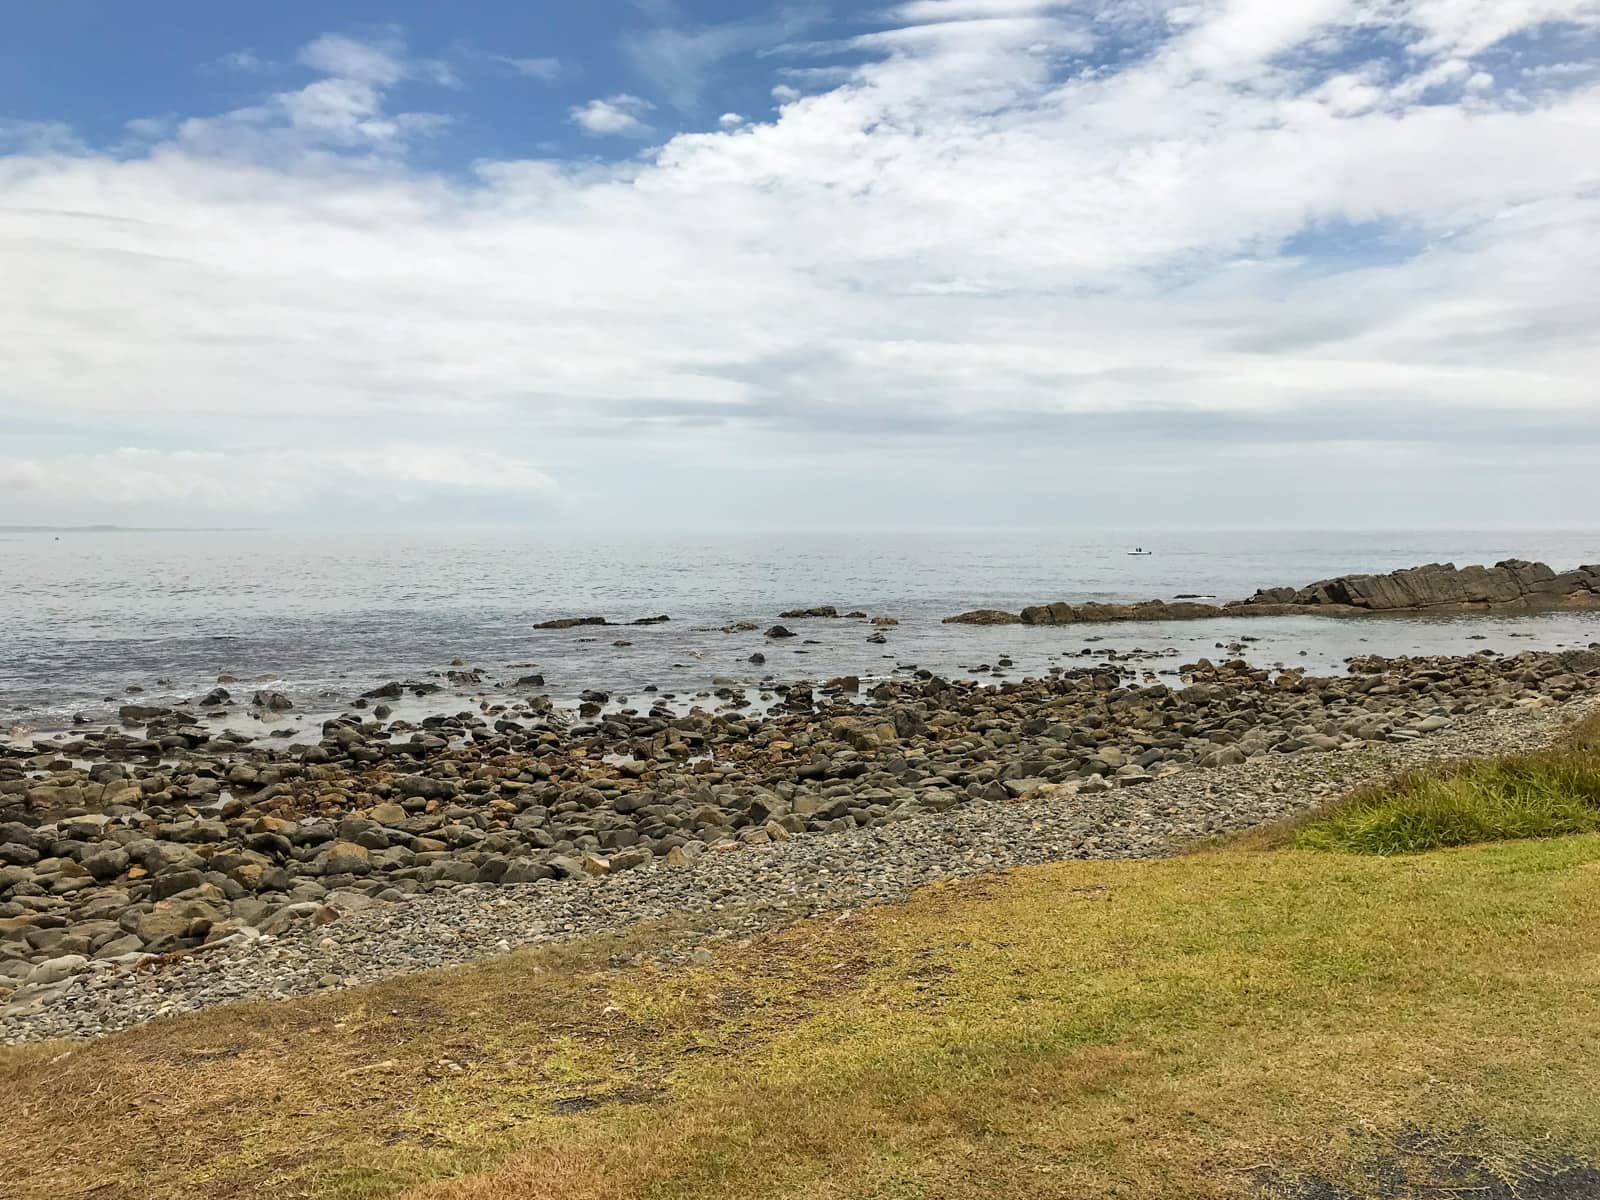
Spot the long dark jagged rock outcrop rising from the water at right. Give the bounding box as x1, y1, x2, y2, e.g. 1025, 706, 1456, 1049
946, 558, 1600, 626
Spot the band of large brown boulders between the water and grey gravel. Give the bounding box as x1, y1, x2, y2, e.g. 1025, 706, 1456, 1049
0, 648, 1600, 1037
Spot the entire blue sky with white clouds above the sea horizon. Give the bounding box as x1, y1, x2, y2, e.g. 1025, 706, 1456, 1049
0, 0, 1600, 533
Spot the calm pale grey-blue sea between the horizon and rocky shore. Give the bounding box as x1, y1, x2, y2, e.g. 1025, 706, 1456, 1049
0, 531, 1600, 733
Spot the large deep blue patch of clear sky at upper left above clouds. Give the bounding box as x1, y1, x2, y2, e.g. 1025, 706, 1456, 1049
0, 0, 882, 171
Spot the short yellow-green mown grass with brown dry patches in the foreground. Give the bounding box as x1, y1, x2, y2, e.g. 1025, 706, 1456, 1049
0, 835, 1600, 1200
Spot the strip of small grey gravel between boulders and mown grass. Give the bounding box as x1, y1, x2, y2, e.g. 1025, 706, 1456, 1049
0, 698, 1600, 1043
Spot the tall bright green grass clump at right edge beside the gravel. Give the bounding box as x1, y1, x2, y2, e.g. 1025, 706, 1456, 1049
1293, 720, 1600, 854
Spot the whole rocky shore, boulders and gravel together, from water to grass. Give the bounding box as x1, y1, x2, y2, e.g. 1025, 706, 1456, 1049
0, 648, 1600, 1040
